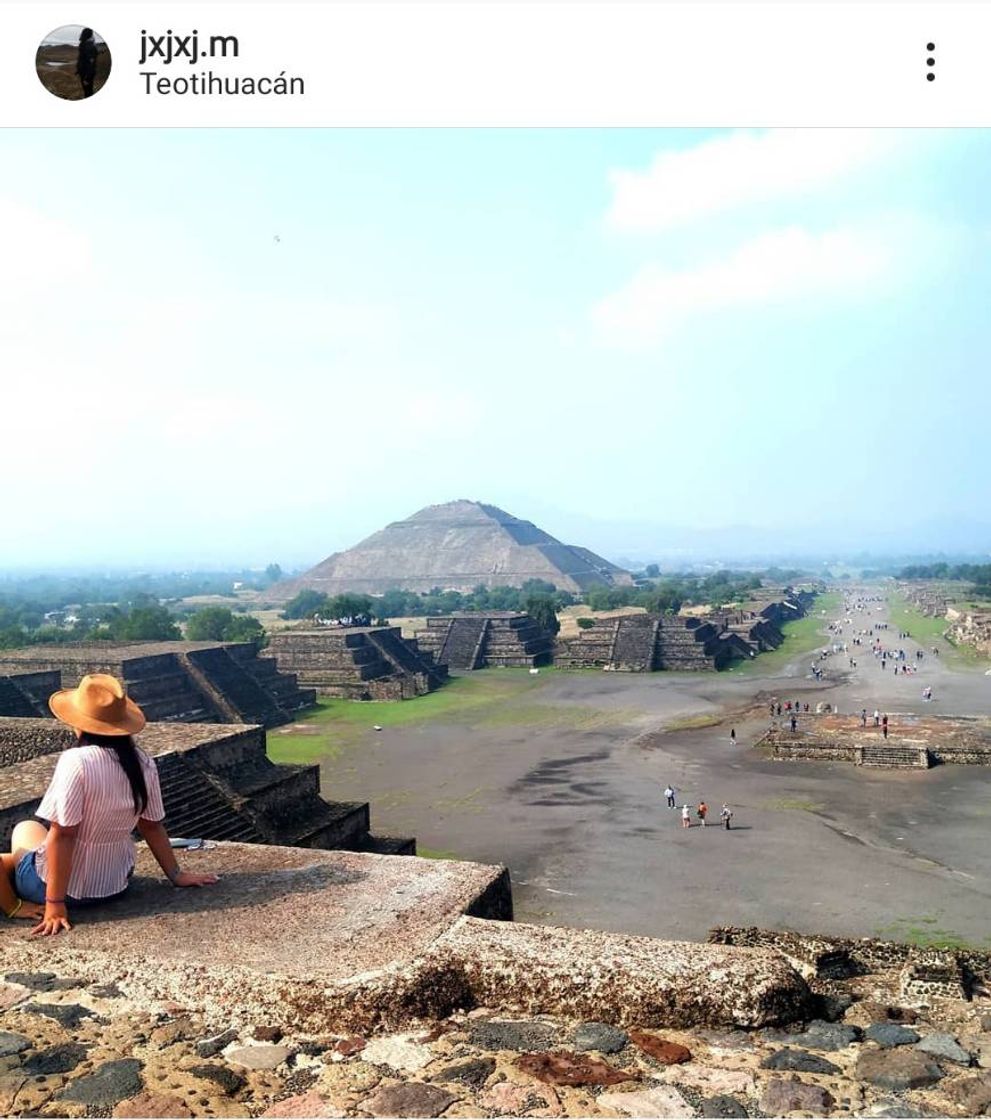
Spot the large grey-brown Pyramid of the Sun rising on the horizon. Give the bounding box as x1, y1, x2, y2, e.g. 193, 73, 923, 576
272, 500, 633, 599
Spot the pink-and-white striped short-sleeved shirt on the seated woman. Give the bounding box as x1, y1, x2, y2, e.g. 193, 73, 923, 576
35, 744, 165, 898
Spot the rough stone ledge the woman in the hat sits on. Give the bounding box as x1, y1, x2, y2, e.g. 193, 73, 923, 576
0, 843, 810, 1034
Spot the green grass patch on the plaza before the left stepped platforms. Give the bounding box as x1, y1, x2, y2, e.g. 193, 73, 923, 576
268, 669, 637, 763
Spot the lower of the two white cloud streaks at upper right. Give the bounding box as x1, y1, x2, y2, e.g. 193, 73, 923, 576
592, 228, 896, 345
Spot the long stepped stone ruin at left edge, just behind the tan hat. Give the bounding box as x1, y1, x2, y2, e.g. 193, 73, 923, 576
0, 642, 317, 727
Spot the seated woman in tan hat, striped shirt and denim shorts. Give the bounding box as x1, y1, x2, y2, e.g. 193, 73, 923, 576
8, 673, 217, 935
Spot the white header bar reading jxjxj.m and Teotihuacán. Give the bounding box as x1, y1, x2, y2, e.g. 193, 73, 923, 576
7, 0, 991, 127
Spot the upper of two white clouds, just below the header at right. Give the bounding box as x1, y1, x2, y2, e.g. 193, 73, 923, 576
607, 129, 899, 233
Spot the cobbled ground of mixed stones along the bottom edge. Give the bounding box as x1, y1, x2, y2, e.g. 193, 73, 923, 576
0, 972, 991, 1117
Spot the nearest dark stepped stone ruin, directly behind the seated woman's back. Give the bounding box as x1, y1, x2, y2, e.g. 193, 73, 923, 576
0, 718, 415, 855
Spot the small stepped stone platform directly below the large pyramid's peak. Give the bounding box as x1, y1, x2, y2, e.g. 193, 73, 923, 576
417, 610, 554, 672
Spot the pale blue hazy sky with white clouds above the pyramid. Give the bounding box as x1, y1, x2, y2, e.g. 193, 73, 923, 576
0, 130, 991, 567
